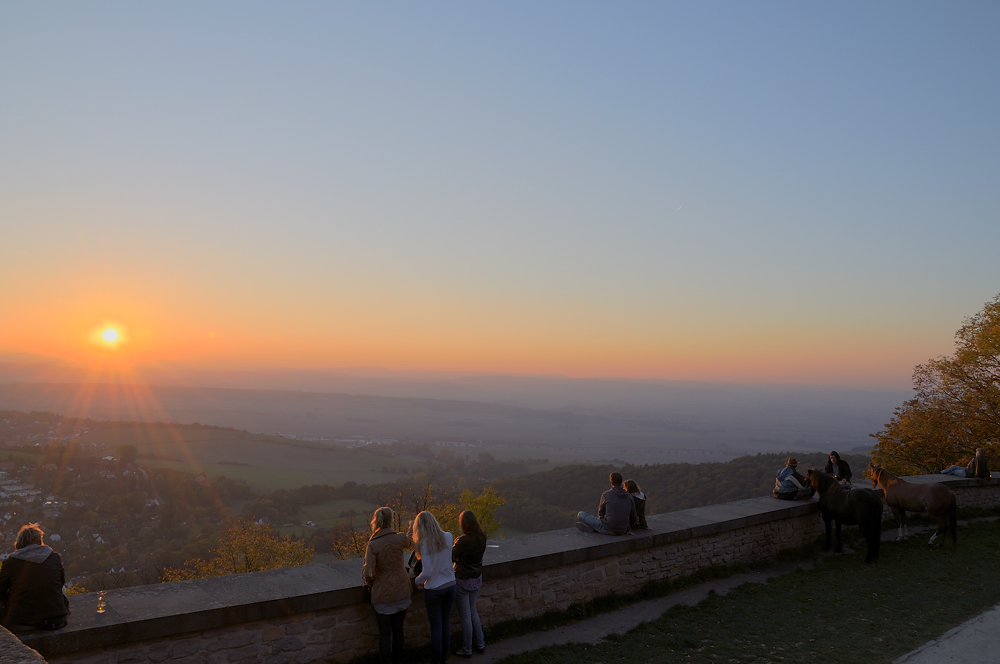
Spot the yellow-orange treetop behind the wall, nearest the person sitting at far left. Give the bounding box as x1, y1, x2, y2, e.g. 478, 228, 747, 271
163, 521, 313, 581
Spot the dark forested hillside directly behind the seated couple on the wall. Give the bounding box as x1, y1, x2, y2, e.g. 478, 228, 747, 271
493, 453, 868, 532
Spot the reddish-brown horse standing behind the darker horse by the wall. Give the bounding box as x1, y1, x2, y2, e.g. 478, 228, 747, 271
868, 464, 958, 546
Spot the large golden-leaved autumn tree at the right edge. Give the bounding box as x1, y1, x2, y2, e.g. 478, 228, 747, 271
872, 295, 1000, 474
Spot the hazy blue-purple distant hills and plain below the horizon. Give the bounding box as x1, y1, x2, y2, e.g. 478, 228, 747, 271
0, 362, 908, 462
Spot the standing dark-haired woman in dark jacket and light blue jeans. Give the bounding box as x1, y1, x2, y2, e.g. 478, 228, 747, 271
451, 510, 486, 657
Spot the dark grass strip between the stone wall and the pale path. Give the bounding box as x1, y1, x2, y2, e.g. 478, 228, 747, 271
501, 522, 1000, 664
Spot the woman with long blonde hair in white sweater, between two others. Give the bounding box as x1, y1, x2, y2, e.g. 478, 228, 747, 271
413, 512, 455, 664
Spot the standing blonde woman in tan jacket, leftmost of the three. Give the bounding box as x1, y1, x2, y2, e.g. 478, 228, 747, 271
361, 507, 413, 664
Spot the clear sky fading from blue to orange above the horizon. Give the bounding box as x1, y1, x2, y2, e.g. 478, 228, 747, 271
0, 1, 1000, 387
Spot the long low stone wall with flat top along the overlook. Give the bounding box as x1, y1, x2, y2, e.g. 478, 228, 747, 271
22, 476, 1000, 664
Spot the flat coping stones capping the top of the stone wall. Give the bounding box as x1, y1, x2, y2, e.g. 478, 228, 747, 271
21, 475, 1000, 656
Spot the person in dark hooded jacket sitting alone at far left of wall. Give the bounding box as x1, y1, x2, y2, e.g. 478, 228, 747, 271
0, 523, 69, 630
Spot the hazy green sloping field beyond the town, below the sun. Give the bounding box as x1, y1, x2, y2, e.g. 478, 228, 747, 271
74, 424, 422, 490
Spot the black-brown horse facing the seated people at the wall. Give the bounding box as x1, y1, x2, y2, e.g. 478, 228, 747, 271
806, 468, 882, 563
